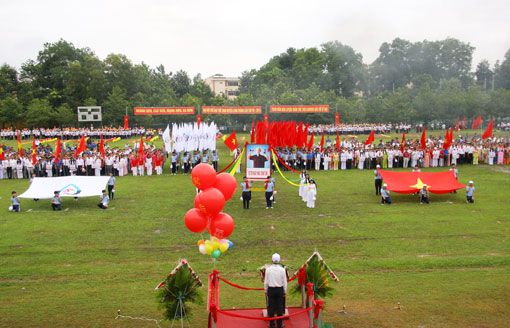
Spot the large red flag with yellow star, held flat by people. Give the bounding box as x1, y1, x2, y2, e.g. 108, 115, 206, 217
379, 170, 466, 194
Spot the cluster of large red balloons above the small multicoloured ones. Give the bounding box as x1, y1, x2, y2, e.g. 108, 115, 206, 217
184, 163, 237, 239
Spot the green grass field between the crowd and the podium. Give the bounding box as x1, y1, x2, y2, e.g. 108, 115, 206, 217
0, 131, 510, 327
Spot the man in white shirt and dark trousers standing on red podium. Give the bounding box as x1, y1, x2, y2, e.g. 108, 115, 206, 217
264, 253, 287, 328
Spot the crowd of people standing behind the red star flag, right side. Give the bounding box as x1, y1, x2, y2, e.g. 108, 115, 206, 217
273, 135, 510, 171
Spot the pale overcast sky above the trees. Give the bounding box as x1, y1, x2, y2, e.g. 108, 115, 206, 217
0, 0, 510, 77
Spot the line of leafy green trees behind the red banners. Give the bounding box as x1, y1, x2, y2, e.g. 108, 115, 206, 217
0, 38, 510, 127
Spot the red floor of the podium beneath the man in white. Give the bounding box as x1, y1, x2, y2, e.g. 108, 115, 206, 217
212, 307, 310, 328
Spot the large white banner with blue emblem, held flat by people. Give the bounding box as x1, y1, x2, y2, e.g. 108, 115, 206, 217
19, 176, 110, 199
